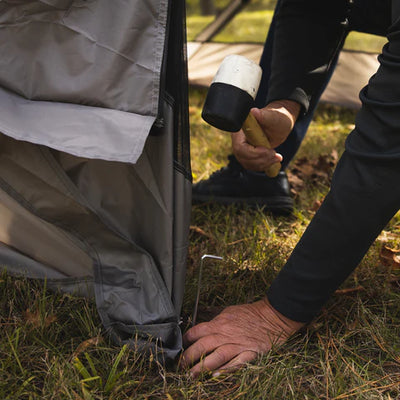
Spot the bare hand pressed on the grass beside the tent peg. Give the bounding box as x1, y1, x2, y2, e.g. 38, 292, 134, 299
182, 298, 304, 377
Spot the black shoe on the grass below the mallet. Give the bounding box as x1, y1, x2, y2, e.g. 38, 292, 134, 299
192, 155, 293, 214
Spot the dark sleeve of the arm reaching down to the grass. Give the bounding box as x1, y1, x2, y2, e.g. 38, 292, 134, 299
267, 0, 400, 322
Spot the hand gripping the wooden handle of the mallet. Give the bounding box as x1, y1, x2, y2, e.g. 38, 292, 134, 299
231, 100, 300, 171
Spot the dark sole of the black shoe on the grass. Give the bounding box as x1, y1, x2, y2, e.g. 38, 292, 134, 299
192, 195, 293, 214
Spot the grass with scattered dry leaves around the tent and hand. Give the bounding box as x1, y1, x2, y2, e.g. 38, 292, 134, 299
0, 90, 400, 400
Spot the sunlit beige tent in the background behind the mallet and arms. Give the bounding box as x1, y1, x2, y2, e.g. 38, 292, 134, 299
188, 0, 379, 109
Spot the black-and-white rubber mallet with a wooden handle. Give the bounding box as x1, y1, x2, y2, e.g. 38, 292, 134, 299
201, 55, 281, 177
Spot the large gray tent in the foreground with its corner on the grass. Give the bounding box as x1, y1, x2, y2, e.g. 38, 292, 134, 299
0, 0, 191, 359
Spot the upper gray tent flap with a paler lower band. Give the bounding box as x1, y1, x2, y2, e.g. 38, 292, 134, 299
0, 0, 168, 163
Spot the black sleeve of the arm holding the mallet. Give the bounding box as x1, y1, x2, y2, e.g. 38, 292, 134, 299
267, 0, 350, 111
